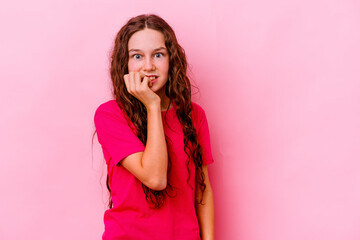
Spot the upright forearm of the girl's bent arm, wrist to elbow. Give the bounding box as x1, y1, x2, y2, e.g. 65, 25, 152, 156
141, 104, 168, 185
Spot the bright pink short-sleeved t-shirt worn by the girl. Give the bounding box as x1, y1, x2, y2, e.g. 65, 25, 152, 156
94, 100, 214, 240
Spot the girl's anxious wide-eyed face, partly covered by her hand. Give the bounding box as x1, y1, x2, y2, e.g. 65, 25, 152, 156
128, 28, 169, 96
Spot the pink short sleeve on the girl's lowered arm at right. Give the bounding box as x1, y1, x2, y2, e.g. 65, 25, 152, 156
194, 104, 214, 165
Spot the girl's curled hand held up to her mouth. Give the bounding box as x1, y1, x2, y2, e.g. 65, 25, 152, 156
124, 72, 161, 108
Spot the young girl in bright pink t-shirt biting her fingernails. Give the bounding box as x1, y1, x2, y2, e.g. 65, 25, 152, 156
94, 15, 214, 240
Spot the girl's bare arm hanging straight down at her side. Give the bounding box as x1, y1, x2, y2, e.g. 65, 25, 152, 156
196, 165, 214, 240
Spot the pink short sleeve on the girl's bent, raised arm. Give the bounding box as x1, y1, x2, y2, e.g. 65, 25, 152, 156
94, 102, 145, 165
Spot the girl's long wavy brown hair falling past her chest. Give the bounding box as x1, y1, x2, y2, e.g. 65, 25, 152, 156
106, 14, 206, 208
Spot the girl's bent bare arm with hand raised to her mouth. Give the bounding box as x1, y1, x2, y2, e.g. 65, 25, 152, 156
120, 72, 168, 191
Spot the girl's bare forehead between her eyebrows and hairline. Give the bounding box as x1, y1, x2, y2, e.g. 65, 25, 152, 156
128, 28, 165, 51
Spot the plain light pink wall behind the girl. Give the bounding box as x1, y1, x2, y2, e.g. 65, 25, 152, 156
0, 0, 360, 240
